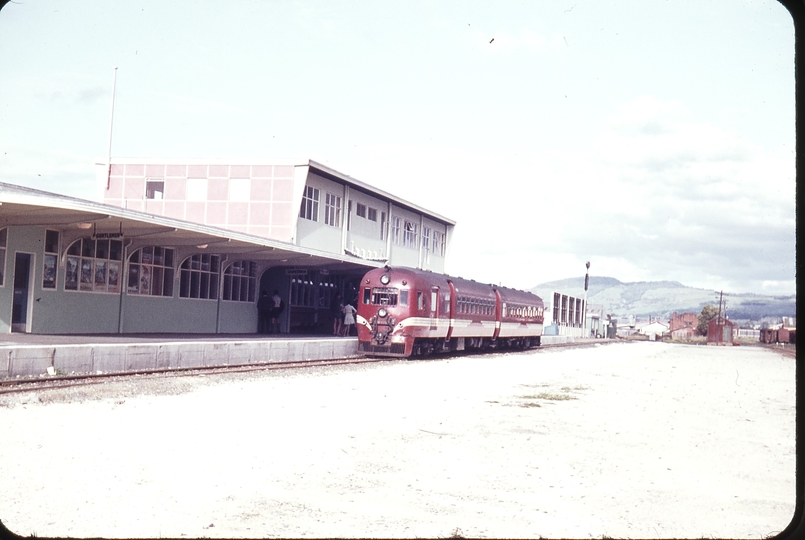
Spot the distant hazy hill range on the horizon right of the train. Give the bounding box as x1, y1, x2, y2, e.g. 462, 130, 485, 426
531, 276, 797, 321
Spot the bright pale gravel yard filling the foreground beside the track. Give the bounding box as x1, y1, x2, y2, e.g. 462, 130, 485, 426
0, 342, 795, 538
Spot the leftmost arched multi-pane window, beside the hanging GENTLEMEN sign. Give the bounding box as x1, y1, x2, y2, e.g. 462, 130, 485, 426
64, 238, 123, 293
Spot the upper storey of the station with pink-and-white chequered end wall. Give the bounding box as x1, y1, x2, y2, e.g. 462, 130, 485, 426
96, 159, 455, 272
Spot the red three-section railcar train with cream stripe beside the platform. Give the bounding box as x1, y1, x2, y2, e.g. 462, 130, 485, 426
356, 266, 545, 357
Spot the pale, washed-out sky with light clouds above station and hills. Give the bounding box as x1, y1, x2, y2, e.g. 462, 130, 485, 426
0, 0, 796, 294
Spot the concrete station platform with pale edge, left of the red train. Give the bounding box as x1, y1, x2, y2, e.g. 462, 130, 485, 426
0, 334, 358, 379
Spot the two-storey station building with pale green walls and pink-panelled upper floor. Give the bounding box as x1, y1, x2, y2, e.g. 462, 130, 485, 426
0, 159, 455, 334
